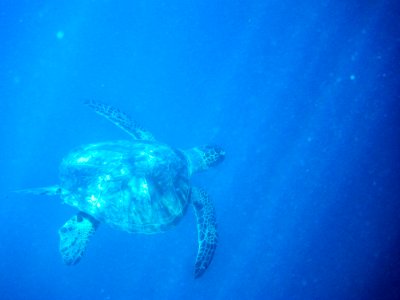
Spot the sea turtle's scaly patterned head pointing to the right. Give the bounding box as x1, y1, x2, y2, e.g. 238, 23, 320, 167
185, 145, 225, 174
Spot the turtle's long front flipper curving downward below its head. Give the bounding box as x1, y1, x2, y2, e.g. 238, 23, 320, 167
191, 188, 218, 278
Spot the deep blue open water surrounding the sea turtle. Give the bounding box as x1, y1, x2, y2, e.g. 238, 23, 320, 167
0, 0, 400, 300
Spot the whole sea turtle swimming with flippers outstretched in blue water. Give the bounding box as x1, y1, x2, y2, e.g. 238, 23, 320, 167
21, 101, 225, 278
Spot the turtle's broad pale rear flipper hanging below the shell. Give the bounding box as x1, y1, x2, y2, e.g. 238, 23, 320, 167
58, 212, 99, 265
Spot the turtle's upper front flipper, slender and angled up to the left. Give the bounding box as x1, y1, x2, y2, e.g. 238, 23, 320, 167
85, 100, 155, 141
